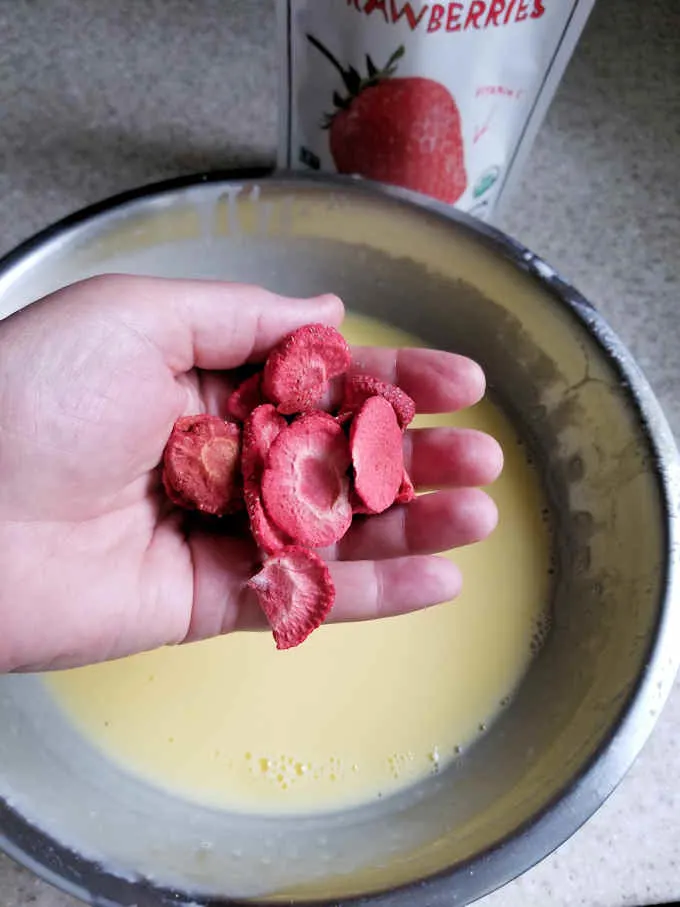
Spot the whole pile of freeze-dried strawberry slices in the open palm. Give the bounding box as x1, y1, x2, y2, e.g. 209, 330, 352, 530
163, 324, 415, 649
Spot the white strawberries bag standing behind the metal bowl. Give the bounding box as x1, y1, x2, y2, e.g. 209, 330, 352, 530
279, 0, 594, 219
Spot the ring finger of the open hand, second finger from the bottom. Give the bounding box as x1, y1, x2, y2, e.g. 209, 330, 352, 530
336, 488, 498, 561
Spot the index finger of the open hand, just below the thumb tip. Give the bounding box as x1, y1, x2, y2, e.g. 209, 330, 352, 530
350, 347, 486, 413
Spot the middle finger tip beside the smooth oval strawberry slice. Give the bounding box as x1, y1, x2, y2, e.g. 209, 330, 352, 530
404, 428, 503, 488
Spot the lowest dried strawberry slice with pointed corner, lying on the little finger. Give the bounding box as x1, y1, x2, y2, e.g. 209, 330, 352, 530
248, 545, 335, 649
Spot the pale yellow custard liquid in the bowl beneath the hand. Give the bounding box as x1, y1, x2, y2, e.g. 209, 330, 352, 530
45, 316, 550, 813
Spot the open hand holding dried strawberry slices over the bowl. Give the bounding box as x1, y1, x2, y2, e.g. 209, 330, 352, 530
0, 276, 502, 671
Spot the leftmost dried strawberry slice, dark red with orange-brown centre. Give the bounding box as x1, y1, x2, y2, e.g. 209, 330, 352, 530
163, 415, 243, 516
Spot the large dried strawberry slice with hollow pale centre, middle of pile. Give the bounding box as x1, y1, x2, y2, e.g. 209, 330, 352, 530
262, 412, 354, 548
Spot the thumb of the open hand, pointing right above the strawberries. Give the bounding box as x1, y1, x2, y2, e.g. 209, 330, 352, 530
51, 274, 344, 373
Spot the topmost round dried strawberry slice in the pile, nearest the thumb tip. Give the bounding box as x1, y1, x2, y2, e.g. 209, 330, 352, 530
262, 324, 351, 415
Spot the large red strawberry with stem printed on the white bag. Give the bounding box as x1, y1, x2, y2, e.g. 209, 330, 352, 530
307, 35, 467, 204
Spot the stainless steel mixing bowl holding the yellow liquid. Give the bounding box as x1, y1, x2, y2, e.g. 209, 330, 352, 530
0, 176, 680, 907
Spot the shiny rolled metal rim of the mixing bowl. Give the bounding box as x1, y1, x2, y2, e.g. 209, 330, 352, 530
0, 168, 680, 907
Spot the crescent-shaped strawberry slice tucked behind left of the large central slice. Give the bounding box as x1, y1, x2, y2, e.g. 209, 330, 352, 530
241, 403, 291, 554
